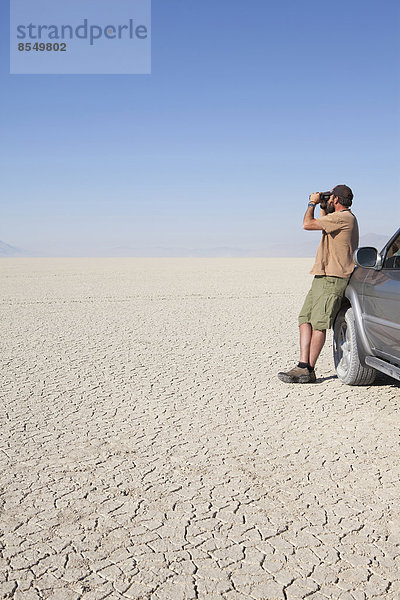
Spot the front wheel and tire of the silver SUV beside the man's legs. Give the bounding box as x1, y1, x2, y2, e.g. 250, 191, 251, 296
333, 308, 376, 385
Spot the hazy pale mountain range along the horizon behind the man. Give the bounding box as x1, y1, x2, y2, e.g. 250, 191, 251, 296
0, 233, 389, 258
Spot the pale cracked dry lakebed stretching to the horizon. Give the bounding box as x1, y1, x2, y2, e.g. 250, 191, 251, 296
0, 259, 400, 600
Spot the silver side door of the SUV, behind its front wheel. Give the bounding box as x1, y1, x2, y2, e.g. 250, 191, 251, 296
362, 233, 400, 364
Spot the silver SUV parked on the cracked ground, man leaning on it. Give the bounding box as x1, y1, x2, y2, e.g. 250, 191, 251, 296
333, 229, 400, 385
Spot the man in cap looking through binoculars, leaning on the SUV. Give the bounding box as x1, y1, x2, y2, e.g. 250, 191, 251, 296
278, 185, 358, 383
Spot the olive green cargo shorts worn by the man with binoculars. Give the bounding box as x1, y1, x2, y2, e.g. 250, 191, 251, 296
299, 275, 349, 331
